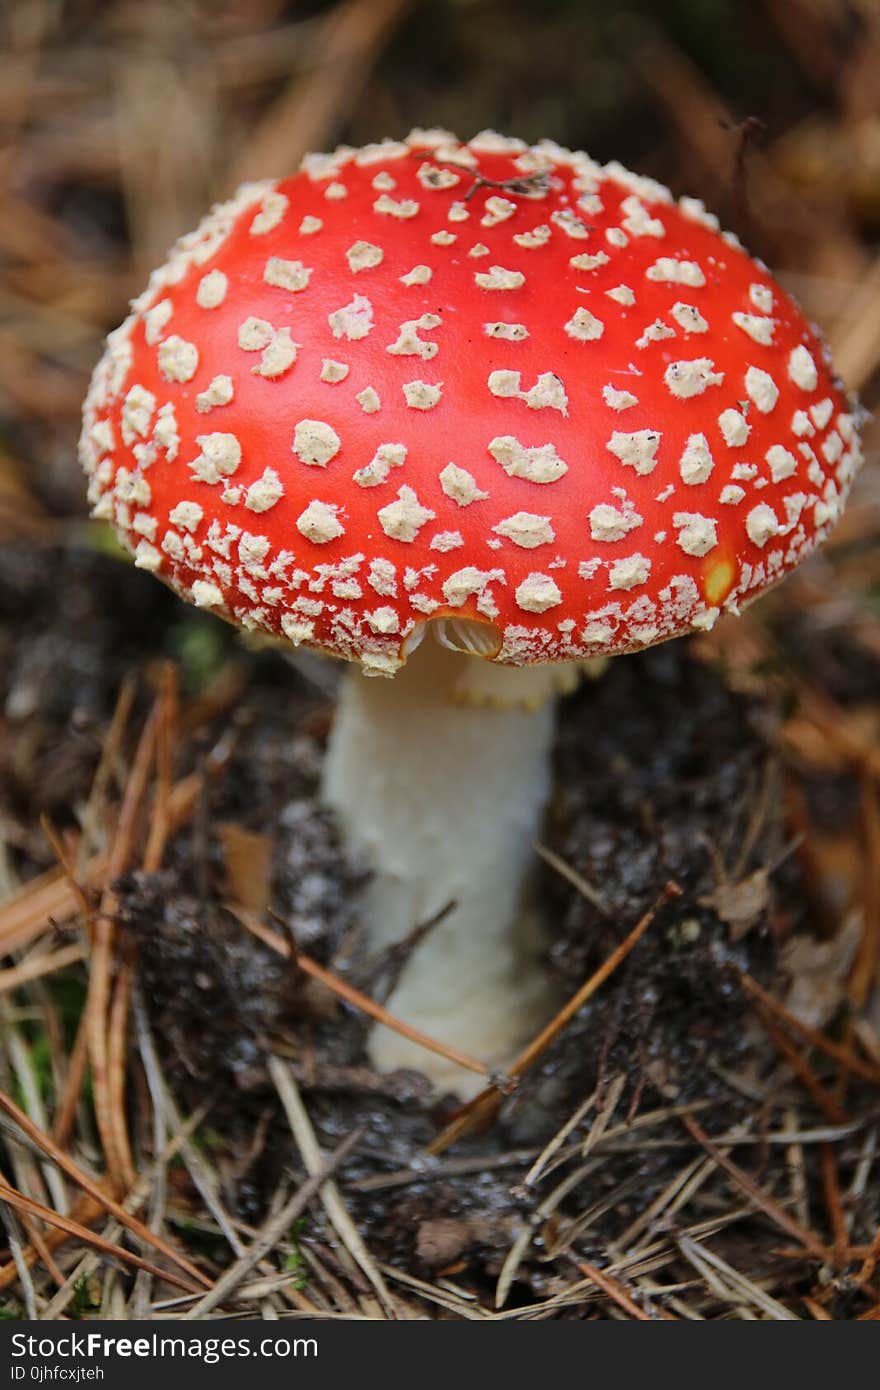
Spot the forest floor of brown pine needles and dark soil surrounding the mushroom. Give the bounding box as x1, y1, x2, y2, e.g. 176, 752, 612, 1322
0, 0, 880, 1321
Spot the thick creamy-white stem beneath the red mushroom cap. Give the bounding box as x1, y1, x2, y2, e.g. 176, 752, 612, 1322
324, 635, 553, 1095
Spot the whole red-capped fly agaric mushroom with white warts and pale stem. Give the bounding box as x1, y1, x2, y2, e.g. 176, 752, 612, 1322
82, 131, 859, 1088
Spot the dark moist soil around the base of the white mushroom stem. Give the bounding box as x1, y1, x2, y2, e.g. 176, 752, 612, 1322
0, 548, 867, 1297
